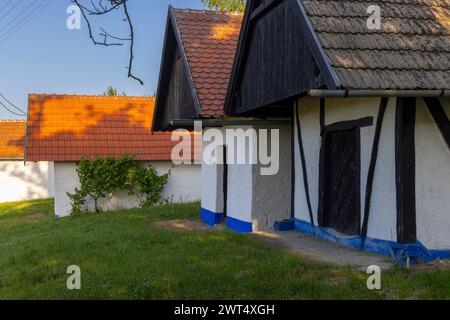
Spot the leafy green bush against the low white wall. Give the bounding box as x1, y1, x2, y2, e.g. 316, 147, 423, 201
67, 154, 170, 214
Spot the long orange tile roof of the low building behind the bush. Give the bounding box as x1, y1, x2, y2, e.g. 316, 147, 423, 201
26, 95, 199, 161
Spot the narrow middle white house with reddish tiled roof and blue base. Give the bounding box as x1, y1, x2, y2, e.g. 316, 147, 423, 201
153, 7, 291, 232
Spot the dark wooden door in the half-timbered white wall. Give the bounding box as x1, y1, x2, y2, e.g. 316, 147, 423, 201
321, 128, 361, 235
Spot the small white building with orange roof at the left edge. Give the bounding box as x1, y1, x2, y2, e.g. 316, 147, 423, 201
0, 120, 54, 203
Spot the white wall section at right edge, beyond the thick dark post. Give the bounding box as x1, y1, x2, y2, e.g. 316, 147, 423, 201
415, 99, 450, 249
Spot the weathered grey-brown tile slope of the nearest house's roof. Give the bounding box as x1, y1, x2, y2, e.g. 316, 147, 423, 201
302, 0, 450, 90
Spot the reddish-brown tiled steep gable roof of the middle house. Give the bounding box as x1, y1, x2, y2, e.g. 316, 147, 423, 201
155, 7, 242, 129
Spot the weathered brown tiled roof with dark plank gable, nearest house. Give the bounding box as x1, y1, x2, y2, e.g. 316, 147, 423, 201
225, 0, 450, 114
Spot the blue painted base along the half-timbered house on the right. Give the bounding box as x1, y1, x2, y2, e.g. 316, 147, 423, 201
294, 219, 450, 263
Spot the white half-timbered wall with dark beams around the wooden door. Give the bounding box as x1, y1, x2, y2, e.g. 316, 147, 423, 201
294, 98, 450, 250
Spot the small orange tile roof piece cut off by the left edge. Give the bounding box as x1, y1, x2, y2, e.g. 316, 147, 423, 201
0, 120, 26, 160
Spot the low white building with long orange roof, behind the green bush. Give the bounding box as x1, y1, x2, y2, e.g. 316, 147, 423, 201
25, 95, 200, 217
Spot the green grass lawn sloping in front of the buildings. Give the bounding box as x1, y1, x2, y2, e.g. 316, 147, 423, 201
0, 201, 450, 299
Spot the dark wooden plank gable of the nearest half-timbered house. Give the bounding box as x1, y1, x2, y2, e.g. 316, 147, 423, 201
225, 0, 339, 114
